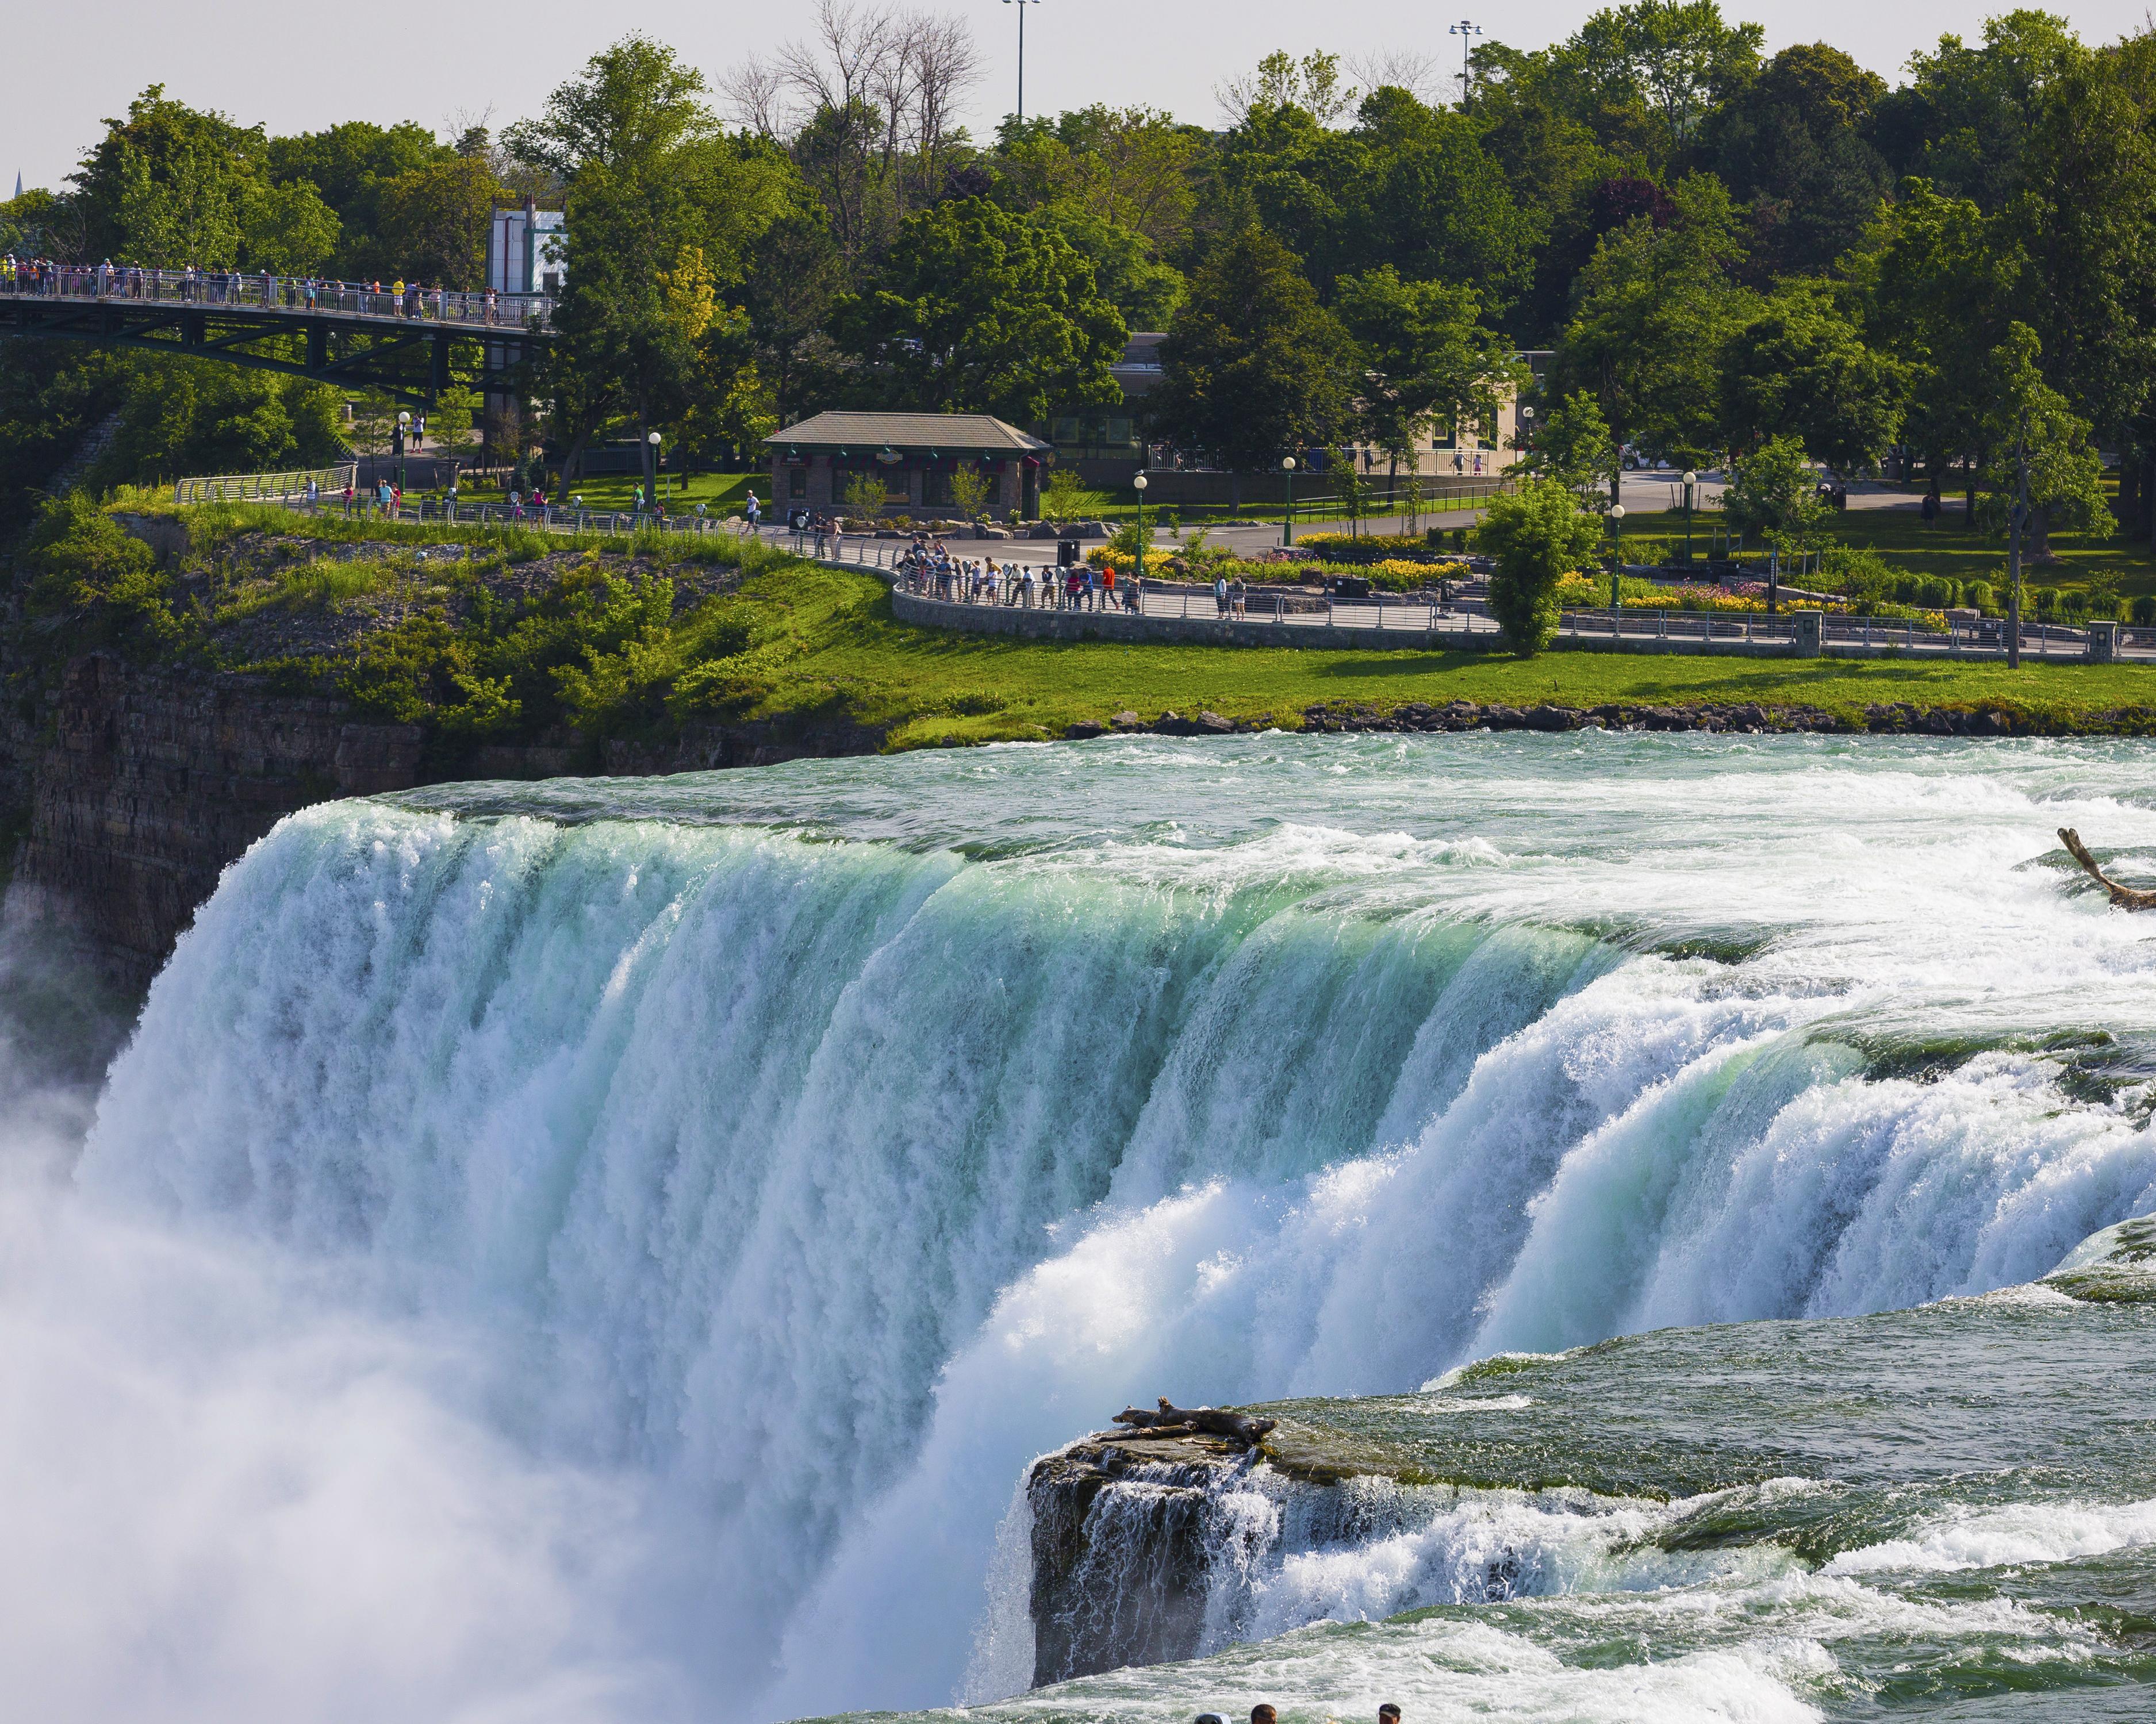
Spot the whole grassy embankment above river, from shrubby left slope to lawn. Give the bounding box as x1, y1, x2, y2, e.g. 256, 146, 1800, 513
30, 506, 2156, 752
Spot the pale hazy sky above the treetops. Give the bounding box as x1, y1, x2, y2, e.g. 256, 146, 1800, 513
0, 0, 2147, 196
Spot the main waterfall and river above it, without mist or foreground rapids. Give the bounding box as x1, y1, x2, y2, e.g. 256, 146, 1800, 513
51, 737, 2156, 1718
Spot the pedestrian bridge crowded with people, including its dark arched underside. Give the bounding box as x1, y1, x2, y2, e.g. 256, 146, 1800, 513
0, 265, 554, 408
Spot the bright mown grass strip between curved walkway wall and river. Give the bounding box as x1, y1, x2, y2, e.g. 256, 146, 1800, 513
711, 567, 2156, 748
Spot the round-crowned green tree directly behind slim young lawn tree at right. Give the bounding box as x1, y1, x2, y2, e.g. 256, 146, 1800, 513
1723, 280, 1906, 474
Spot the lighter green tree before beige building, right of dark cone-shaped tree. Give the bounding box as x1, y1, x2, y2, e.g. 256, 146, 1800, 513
1334, 263, 1509, 485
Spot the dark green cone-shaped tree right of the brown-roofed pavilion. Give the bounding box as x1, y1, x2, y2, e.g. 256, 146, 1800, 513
1152, 228, 1350, 506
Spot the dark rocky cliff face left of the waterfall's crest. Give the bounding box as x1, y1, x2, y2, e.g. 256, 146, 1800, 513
0, 653, 882, 987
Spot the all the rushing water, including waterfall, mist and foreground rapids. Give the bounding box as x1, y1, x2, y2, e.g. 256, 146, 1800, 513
0, 735, 2156, 1724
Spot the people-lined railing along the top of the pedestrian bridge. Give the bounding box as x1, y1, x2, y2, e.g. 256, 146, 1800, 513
0, 263, 554, 330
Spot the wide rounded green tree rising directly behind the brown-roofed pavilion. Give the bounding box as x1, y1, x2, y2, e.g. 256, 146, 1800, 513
833, 198, 1126, 425
